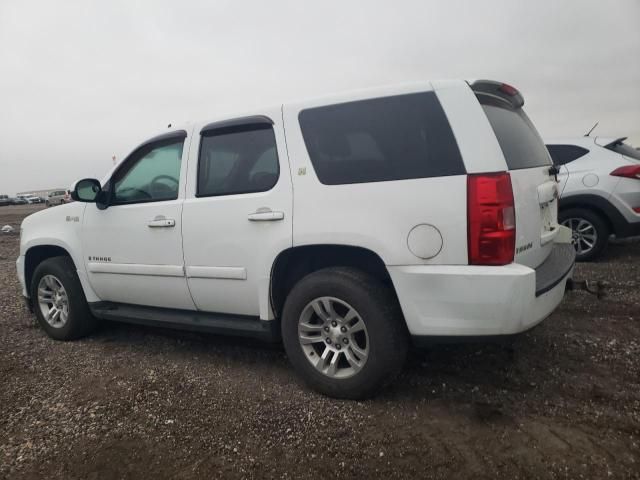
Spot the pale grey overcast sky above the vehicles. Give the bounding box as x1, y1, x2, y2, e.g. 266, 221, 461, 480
0, 0, 640, 194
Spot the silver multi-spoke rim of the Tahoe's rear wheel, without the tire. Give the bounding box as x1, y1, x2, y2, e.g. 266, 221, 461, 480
298, 297, 369, 378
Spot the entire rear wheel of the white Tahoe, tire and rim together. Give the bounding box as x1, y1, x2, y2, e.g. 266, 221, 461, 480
282, 268, 408, 399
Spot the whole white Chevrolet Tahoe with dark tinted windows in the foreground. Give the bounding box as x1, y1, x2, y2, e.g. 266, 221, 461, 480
17, 81, 575, 398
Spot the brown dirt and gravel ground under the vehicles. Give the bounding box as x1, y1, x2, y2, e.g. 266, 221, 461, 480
0, 206, 640, 479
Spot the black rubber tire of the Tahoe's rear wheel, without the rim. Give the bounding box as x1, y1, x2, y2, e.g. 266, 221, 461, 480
282, 267, 409, 399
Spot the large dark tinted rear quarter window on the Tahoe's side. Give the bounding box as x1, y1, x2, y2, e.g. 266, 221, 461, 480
299, 92, 466, 185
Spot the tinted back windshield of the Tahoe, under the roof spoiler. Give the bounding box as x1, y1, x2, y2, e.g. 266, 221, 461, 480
478, 95, 551, 170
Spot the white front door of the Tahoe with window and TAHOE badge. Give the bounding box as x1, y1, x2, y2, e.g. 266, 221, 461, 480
82, 130, 195, 310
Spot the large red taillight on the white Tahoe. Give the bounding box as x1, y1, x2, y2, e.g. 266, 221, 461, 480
467, 172, 516, 265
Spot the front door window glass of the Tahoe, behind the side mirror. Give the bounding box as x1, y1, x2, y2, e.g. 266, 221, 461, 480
113, 138, 184, 204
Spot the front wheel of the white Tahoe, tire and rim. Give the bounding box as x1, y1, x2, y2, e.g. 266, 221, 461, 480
31, 257, 96, 340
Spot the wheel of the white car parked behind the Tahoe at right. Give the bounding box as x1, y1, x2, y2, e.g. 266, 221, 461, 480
559, 208, 611, 262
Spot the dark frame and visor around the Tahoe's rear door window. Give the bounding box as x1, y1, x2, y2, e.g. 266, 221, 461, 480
194, 124, 281, 198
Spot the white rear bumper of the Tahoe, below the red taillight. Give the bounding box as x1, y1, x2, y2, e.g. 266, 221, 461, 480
388, 244, 575, 337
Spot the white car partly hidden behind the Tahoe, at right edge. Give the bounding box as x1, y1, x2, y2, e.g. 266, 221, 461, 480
547, 136, 640, 261
